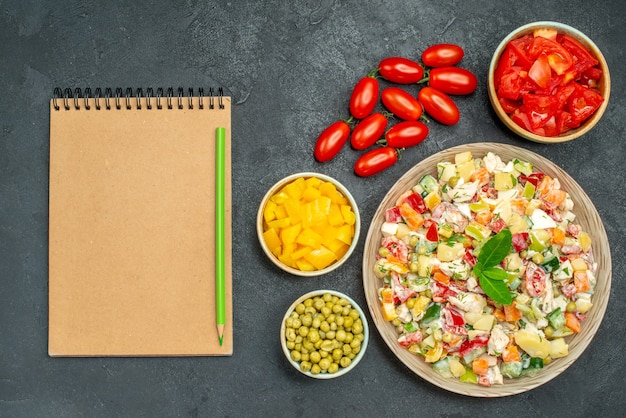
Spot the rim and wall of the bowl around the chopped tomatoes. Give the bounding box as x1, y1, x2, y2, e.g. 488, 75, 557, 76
487, 21, 611, 144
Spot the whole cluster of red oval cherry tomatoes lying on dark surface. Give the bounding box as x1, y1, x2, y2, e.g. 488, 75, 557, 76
314, 43, 478, 177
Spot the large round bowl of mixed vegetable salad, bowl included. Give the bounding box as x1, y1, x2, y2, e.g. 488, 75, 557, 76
363, 143, 611, 397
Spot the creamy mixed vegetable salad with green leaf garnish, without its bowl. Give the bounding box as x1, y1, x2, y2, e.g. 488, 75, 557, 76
373, 152, 597, 386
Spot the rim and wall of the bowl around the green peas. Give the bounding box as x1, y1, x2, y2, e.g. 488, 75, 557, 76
280, 289, 369, 379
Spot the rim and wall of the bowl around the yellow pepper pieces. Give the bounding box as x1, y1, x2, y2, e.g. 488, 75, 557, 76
256, 172, 361, 277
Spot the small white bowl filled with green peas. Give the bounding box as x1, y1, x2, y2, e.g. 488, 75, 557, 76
280, 289, 369, 379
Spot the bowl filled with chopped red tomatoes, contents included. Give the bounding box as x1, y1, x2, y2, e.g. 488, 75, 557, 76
488, 22, 611, 143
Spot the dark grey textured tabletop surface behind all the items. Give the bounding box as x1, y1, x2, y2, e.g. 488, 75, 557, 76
0, 0, 626, 417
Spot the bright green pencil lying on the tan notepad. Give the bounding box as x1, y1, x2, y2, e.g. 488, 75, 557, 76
215, 128, 226, 345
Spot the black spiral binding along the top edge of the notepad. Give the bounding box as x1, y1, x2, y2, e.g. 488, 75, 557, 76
52, 87, 224, 110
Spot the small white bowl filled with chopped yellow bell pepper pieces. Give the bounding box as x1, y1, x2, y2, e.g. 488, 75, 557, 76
257, 172, 361, 277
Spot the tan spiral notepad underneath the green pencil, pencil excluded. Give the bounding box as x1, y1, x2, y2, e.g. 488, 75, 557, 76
48, 89, 233, 356
